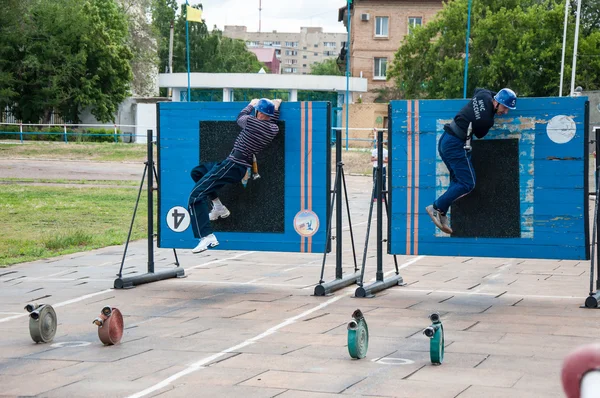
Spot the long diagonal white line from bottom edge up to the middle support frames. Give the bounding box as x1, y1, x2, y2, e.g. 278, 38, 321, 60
129, 295, 346, 398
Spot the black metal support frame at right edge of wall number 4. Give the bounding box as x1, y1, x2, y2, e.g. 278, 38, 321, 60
314, 130, 360, 296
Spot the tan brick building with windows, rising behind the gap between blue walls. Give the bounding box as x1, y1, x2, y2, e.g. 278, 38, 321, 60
338, 0, 442, 102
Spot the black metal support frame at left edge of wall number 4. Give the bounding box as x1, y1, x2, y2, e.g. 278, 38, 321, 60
114, 130, 185, 289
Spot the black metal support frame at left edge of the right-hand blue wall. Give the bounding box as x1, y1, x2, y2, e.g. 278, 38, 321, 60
354, 130, 404, 298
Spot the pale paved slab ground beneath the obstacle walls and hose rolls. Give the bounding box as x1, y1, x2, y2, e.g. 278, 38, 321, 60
0, 176, 600, 398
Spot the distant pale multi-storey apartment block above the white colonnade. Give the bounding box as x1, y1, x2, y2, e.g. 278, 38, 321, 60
223, 25, 348, 75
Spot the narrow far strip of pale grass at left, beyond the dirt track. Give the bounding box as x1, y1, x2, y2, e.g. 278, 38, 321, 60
0, 141, 156, 162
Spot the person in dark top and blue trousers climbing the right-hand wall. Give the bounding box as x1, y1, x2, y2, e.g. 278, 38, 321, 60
426, 88, 517, 234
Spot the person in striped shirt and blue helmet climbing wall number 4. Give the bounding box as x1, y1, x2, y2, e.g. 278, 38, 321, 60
188, 98, 281, 253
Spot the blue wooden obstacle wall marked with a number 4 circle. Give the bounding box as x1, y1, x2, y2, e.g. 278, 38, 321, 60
157, 102, 331, 252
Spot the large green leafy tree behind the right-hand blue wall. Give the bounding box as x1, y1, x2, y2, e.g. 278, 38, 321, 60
388, 0, 600, 98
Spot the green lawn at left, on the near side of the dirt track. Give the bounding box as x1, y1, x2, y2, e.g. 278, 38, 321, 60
0, 185, 147, 267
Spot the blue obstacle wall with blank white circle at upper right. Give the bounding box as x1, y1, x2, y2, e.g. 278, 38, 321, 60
388, 97, 589, 259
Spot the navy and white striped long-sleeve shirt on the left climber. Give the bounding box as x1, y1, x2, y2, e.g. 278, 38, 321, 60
229, 105, 279, 167
